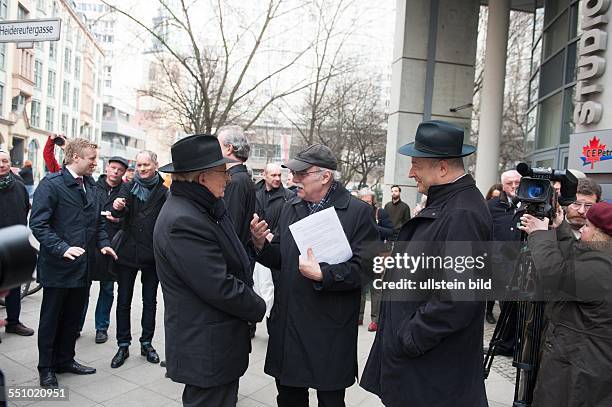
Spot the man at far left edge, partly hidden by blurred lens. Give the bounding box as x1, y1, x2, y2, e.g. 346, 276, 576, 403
0, 149, 34, 342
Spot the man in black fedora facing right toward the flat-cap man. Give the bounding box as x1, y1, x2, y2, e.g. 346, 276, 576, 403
154, 135, 266, 407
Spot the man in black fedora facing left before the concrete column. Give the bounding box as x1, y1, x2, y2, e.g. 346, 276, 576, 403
360, 120, 492, 407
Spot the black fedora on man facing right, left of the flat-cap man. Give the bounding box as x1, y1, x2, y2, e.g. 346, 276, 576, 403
159, 134, 238, 173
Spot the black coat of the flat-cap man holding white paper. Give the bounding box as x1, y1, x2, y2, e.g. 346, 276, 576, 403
258, 187, 378, 390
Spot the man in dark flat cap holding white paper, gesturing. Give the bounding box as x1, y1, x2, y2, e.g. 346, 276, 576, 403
251, 144, 378, 407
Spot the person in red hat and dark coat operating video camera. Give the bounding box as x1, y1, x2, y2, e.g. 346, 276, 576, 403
520, 202, 612, 407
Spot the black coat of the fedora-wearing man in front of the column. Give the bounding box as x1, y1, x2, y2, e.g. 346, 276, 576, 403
361, 175, 492, 407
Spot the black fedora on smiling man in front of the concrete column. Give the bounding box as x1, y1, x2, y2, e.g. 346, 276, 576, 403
399, 120, 476, 158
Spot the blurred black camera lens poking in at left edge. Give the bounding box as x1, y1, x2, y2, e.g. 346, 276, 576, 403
0, 225, 36, 291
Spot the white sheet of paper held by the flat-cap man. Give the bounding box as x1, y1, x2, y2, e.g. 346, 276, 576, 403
289, 207, 353, 264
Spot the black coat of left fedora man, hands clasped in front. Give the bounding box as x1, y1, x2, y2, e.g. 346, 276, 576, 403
154, 184, 266, 387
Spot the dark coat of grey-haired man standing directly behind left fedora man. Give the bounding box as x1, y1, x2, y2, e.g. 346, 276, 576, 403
223, 164, 255, 248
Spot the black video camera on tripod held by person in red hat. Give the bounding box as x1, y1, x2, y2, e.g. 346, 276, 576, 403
516, 163, 578, 221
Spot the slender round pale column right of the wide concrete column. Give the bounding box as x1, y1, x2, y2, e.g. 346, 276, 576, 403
476, 0, 510, 194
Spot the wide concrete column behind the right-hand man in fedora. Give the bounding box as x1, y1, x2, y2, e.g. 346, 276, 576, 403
383, 0, 480, 207
